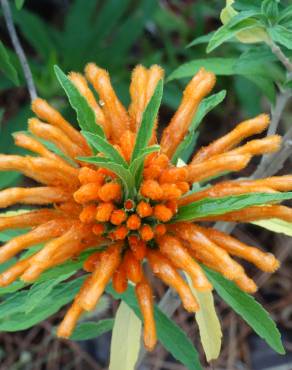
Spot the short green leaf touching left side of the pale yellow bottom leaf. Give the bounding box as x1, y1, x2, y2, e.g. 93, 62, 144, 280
70, 319, 114, 340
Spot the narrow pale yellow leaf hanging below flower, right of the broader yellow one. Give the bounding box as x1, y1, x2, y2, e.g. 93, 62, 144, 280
186, 274, 222, 362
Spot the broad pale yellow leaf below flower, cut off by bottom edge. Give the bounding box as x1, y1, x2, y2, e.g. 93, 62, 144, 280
109, 302, 142, 370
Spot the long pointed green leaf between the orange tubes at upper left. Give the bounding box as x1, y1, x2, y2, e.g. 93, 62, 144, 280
54, 65, 105, 138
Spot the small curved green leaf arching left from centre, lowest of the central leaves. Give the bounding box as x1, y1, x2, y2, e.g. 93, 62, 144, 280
78, 157, 135, 199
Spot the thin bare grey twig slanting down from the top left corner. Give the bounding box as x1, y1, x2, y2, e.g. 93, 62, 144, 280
1, 0, 37, 100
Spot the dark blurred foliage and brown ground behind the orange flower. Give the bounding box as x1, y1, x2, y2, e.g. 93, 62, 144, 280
0, 0, 292, 370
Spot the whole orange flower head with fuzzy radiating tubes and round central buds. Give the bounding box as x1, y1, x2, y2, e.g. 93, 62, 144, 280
0, 64, 292, 350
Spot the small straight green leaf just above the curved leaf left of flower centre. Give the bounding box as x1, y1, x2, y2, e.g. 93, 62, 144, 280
81, 131, 129, 168
